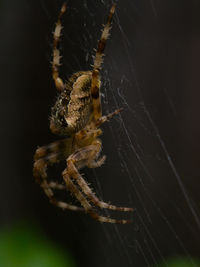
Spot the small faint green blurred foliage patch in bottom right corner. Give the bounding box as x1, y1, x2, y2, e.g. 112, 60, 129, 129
159, 257, 200, 267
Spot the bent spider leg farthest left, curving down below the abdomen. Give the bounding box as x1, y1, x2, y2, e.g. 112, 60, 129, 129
33, 153, 84, 211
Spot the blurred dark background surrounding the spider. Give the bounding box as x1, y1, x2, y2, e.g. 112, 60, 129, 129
0, 0, 200, 267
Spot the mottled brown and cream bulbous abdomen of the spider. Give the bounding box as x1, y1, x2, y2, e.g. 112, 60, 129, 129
50, 71, 92, 135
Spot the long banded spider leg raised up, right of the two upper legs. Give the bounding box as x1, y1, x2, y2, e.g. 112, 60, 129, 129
91, 4, 115, 121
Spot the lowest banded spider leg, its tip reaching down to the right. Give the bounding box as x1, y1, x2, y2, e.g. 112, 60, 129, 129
63, 169, 131, 224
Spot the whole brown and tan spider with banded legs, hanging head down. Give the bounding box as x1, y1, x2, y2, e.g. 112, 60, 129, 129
33, 3, 133, 224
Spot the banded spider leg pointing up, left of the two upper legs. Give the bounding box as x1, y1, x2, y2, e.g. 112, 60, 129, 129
52, 3, 67, 91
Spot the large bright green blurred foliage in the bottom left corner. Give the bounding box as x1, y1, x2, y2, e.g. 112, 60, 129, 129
0, 224, 75, 267
